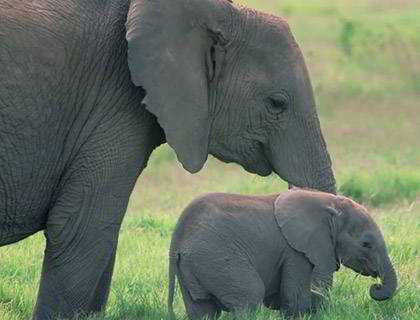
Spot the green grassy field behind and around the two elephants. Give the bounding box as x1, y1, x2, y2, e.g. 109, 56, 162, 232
0, 0, 420, 320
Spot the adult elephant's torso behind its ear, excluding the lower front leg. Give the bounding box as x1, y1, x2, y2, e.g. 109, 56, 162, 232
0, 1, 164, 244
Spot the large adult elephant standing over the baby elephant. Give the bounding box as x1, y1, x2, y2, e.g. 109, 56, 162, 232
0, 0, 335, 320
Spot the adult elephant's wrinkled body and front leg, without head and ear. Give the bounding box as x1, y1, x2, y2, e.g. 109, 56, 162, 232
0, 1, 164, 320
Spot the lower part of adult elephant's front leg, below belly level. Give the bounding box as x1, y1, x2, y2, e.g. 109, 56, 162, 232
34, 209, 119, 320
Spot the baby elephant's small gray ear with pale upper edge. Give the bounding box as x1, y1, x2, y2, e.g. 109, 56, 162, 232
275, 190, 339, 277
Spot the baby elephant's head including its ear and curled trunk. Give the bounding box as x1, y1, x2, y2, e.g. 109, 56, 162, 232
276, 190, 397, 300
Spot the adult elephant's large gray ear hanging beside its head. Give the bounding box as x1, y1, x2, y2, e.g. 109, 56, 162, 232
126, 0, 228, 172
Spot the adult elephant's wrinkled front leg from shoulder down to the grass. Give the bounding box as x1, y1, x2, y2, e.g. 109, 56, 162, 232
33, 106, 161, 320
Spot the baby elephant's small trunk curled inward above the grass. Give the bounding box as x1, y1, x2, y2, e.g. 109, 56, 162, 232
370, 253, 398, 301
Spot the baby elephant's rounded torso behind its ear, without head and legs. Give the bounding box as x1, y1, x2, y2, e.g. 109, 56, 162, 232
171, 194, 288, 309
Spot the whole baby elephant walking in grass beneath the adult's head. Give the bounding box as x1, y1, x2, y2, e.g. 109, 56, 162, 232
168, 189, 397, 320
